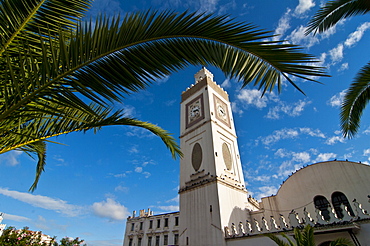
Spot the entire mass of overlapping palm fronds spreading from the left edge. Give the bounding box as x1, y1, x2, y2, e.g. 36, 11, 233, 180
0, 0, 325, 190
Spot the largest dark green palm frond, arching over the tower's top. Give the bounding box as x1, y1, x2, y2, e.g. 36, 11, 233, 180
0, 12, 325, 123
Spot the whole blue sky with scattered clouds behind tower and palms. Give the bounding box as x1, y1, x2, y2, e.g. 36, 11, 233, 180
0, 0, 370, 246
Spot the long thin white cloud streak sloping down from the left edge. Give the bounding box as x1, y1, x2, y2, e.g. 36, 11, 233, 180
0, 188, 82, 217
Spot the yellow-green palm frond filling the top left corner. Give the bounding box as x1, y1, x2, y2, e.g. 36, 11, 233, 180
0, 0, 92, 56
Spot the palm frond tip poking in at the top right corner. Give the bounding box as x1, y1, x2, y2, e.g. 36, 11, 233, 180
306, 0, 370, 35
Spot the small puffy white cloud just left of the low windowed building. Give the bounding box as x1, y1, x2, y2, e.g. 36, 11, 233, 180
92, 198, 130, 220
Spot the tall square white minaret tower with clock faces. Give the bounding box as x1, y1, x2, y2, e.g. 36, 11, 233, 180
179, 68, 251, 246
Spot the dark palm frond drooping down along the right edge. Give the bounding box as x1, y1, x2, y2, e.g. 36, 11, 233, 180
340, 62, 370, 138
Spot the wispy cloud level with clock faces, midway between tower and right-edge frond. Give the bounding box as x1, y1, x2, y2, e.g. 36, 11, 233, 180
266, 100, 311, 119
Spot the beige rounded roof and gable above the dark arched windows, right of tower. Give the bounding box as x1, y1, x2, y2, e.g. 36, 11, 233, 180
268, 161, 370, 210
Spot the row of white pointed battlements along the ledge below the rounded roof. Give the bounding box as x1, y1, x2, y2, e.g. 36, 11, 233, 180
224, 200, 370, 238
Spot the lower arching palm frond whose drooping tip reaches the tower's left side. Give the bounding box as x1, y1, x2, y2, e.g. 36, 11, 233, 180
0, 105, 182, 159
